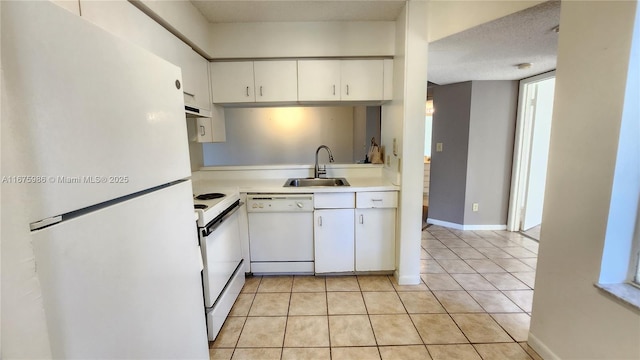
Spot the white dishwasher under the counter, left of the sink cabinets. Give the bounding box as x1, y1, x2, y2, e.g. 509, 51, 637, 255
247, 194, 314, 274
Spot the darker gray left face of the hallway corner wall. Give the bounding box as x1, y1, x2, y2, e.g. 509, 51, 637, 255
429, 82, 471, 224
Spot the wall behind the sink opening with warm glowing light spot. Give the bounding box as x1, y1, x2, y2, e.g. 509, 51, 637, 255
203, 106, 354, 166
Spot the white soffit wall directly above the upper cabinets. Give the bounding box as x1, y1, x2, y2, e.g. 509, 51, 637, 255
210, 21, 395, 59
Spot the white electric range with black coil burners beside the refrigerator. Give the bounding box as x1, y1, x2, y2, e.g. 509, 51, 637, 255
194, 190, 245, 341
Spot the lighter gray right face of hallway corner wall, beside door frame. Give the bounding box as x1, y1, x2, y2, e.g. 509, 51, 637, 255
464, 81, 518, 225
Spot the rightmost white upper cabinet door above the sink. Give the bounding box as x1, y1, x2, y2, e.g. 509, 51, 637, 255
340, 60, 384, 101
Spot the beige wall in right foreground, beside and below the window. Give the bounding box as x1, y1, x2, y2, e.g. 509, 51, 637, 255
529, 1, 640, 359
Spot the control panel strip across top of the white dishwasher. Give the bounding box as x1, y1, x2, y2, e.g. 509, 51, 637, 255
247, 194, 313, 212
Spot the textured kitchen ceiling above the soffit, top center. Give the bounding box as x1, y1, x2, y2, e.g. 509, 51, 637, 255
191, 0, 404, 23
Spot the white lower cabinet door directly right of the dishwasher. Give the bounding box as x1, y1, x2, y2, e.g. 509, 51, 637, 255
313, 209, 354, 273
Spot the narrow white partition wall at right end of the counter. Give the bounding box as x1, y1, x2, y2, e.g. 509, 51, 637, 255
381, 1, 428, 284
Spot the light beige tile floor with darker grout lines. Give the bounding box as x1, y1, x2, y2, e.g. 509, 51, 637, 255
209, 226, 540, 360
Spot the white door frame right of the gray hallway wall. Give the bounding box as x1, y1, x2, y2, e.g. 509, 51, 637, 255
507, 70, 556, 231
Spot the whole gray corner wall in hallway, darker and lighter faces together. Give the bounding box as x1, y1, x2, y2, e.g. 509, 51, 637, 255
429, 81, 518, 225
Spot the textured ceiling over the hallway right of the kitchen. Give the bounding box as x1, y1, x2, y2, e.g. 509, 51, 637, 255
427, 1, 560, 85
